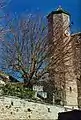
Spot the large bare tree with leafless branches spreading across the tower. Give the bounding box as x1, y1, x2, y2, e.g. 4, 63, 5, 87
2, 10, 73, 99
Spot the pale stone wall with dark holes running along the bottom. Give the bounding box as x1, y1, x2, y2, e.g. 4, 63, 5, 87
0, 96, 65, 120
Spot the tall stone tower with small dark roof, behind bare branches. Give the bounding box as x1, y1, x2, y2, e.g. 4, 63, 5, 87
47, 7, 78, 107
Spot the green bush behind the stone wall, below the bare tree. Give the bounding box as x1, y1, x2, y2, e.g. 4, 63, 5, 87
2, 83, 35, 99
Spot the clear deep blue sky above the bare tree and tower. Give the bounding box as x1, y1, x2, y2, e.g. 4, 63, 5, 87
6, 0, 81, 32
